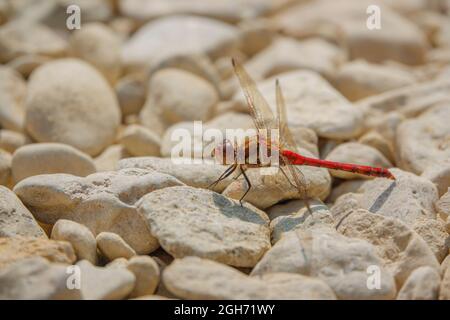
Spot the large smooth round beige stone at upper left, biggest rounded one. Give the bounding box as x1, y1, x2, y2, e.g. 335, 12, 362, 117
25, 58, 120, 156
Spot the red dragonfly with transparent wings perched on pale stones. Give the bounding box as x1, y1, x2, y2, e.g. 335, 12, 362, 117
211, 59, 395, 212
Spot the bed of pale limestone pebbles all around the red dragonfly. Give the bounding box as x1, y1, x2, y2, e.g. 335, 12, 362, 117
0, 0, 450, 299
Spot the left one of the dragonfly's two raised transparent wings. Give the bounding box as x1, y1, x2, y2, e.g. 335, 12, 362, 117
231, 59, 278, 130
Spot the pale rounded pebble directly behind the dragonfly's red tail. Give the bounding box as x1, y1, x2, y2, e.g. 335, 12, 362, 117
325, 142, 392, 179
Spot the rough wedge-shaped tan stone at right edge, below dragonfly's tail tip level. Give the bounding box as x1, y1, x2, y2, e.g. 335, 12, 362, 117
412, 218, 450, 262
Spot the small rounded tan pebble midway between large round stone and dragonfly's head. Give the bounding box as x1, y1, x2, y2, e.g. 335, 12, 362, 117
119, 124, 161, 157
